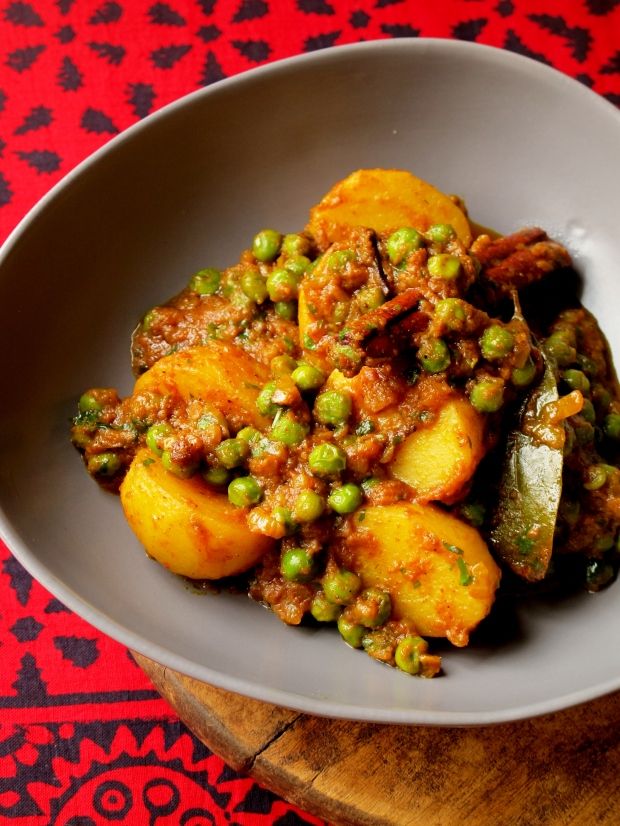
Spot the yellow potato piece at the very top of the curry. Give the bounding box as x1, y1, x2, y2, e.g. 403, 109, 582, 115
308, 169, 472, 246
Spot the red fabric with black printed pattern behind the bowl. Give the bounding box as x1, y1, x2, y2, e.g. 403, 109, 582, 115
0, 0, 620, 826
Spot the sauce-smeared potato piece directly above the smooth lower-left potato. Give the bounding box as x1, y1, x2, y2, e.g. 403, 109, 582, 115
134, 341, 270, 430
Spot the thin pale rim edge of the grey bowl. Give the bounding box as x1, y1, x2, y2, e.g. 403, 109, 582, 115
0, 37, 620, 726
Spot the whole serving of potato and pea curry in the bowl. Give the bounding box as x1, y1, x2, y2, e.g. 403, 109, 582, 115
72, 169, 620, 677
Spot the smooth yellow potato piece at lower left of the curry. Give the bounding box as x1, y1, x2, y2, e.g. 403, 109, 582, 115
120, 449, 272, 579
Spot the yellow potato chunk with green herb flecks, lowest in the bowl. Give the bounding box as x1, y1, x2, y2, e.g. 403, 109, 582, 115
346, 502, 500, 646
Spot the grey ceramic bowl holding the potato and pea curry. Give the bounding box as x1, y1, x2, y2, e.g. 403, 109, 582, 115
0, 40, 620, 724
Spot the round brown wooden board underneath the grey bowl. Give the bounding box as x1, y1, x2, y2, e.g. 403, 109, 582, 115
135, 654, 620, 826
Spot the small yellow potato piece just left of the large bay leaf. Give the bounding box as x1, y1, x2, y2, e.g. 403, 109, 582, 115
389, 398, 485, 504
